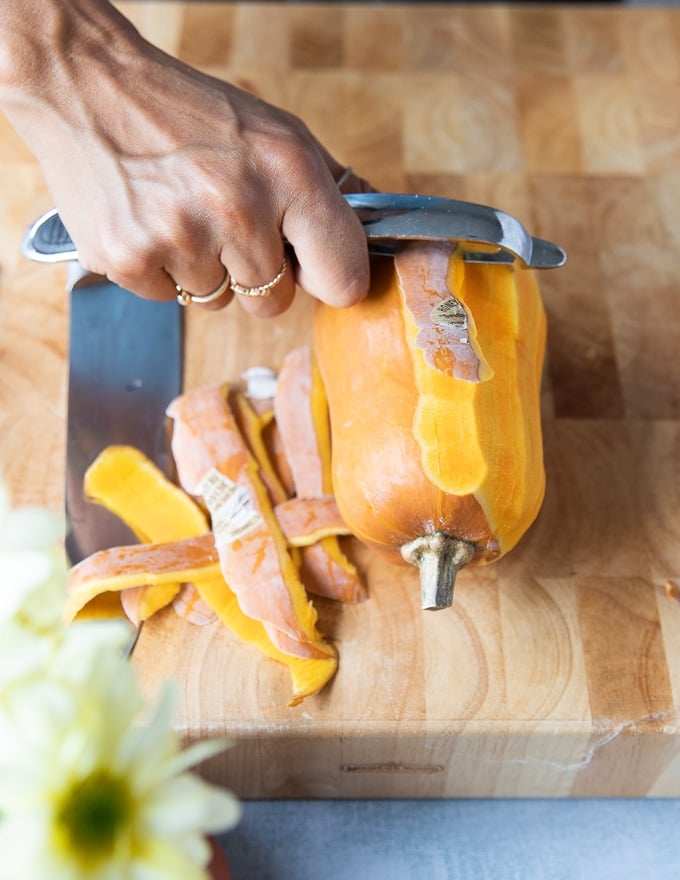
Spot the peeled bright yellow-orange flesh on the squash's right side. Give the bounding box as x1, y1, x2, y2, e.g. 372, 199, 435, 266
407, 258, 545, 553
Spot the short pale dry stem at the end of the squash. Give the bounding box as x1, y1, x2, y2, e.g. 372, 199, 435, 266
401, 532, 475, 611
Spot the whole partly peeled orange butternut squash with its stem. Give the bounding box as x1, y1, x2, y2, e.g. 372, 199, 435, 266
314, 242, 546, 609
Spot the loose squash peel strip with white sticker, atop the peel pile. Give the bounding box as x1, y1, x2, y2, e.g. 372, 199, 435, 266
168, 385, 336, 658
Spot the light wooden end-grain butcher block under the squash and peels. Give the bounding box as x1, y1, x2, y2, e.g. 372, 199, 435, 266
0, 2, 680, 797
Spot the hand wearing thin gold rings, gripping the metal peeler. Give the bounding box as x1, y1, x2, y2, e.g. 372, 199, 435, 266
0, 3, 370, 316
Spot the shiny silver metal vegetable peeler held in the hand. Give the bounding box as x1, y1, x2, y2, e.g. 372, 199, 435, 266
22, 193, 567, 269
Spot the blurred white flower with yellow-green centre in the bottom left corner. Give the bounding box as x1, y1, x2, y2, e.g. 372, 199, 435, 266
0, 650, 239, 880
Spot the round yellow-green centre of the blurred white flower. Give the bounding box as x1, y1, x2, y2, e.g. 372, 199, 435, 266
57, 770, 132, 864
